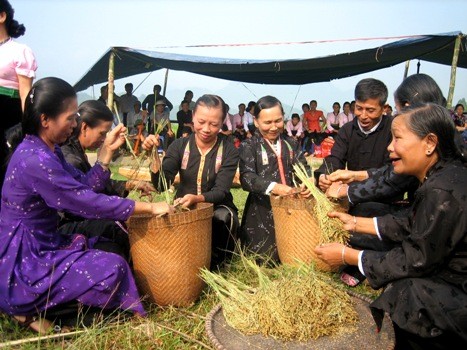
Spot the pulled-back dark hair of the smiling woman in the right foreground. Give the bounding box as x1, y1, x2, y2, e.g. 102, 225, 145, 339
401, 103, 467, 163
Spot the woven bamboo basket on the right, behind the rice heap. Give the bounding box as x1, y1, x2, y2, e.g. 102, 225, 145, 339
271, 196, 331, 271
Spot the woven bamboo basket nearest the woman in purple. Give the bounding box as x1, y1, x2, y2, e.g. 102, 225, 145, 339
128, 203, 213, 306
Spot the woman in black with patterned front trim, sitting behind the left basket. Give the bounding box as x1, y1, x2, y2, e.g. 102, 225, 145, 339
143, 95, 238, 268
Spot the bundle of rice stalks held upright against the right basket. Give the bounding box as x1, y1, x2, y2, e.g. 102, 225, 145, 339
293, 164, 350, 244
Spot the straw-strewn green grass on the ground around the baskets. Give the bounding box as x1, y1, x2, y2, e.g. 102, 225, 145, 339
0, 166, 377, 350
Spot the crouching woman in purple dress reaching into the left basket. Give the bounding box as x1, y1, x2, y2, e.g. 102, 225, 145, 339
0, 78, 170, 333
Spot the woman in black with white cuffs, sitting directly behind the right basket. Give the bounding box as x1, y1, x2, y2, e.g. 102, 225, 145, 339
239, 96, 311, 262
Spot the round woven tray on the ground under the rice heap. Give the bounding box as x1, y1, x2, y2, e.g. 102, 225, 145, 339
205, 292, 395, 350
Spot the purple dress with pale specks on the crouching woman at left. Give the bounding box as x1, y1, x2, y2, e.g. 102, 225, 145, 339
0, 135, 146, 315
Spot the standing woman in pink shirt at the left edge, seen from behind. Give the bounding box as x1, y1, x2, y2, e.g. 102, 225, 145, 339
0, 0, 37, 188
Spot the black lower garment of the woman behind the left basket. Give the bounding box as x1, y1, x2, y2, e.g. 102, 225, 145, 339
211, 205, 238, 269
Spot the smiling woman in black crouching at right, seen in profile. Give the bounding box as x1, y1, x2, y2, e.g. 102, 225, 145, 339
315, 104, 467, 349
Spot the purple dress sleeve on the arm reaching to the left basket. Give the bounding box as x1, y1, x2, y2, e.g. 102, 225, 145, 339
21, 149, 135, 220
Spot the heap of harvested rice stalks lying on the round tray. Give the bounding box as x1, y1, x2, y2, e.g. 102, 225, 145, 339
201, 255, 358, 341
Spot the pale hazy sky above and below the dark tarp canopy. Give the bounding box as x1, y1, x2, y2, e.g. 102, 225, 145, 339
10, 0, 467, 117
